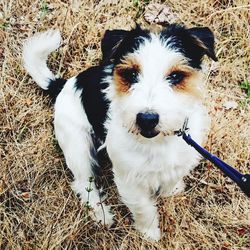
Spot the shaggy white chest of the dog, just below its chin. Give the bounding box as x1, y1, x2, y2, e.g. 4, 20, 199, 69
107, 130, 195, 183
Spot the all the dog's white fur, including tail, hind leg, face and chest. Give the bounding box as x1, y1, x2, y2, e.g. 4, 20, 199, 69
24, 31, 209, 240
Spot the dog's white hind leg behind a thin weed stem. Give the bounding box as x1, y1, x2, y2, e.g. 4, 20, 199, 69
55, 78, 113, 225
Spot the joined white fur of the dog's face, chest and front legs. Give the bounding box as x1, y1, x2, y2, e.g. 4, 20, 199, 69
106, 32, 209, 240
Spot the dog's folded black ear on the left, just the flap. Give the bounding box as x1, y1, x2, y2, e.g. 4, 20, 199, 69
101, 30, 129, 61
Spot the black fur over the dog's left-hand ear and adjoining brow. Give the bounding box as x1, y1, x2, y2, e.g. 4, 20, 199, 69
102, 25, 150, 65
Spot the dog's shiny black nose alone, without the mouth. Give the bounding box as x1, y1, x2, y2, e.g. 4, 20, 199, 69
136, 112, 159, 130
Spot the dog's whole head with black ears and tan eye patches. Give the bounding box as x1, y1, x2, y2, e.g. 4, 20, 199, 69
102, 25, 216, 138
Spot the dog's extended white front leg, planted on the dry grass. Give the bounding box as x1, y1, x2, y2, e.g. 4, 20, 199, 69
115, 177, 160, 240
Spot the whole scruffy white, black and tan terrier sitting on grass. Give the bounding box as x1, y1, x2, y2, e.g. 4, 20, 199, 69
23, 24, 216, 240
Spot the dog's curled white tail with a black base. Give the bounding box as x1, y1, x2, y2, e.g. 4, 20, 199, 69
23, 30, 66, 98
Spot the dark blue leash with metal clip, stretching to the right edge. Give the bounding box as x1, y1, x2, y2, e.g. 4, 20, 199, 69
176, 119, 250, 198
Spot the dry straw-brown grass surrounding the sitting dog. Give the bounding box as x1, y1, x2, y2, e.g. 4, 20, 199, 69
0, 0, 250, 249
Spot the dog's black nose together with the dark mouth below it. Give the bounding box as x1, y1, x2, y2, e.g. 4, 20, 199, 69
136, 112, 159, 138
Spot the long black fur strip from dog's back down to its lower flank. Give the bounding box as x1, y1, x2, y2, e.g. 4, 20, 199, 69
76, 66, 109, 189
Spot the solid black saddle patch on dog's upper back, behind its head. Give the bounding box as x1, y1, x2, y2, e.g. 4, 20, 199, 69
76, 66, 109, 141
